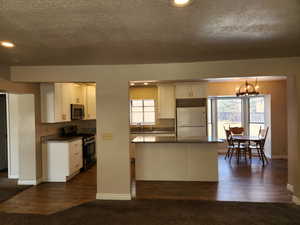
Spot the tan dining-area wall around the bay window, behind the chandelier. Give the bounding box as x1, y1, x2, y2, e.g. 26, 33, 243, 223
208, 80, 287, 158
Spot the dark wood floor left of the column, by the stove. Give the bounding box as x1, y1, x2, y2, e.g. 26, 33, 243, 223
0, 166, 97, 215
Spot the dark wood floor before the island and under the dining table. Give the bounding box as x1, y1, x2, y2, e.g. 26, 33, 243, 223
135, 156, 291, 202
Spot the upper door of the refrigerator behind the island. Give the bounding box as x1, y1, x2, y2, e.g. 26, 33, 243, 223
177, 107, 206, 127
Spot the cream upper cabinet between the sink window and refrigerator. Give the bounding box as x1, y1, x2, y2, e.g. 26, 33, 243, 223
158, 84, 175, 119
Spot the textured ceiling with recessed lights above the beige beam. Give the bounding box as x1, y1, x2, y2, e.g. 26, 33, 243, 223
0, 0, 300, 65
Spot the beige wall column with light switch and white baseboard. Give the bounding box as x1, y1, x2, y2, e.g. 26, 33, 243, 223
96, 78, 131, 200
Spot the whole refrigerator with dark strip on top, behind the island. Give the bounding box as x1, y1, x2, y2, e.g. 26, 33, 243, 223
176, 99, 207, 138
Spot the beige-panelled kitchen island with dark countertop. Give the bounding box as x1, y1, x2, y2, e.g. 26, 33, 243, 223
131, 136, 223, 182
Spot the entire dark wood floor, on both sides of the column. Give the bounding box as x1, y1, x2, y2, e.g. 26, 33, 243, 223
0, 156, 291, 214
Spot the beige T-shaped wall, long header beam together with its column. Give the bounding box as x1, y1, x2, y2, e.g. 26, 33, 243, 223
11, 57, 300, 201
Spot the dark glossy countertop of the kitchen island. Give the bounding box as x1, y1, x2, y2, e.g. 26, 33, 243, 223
131, 135, 224, 144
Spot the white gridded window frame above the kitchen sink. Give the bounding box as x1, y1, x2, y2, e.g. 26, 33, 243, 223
129, 99, 156, 126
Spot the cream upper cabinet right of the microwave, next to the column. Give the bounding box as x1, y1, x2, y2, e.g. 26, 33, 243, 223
84, 86, 96, 120
